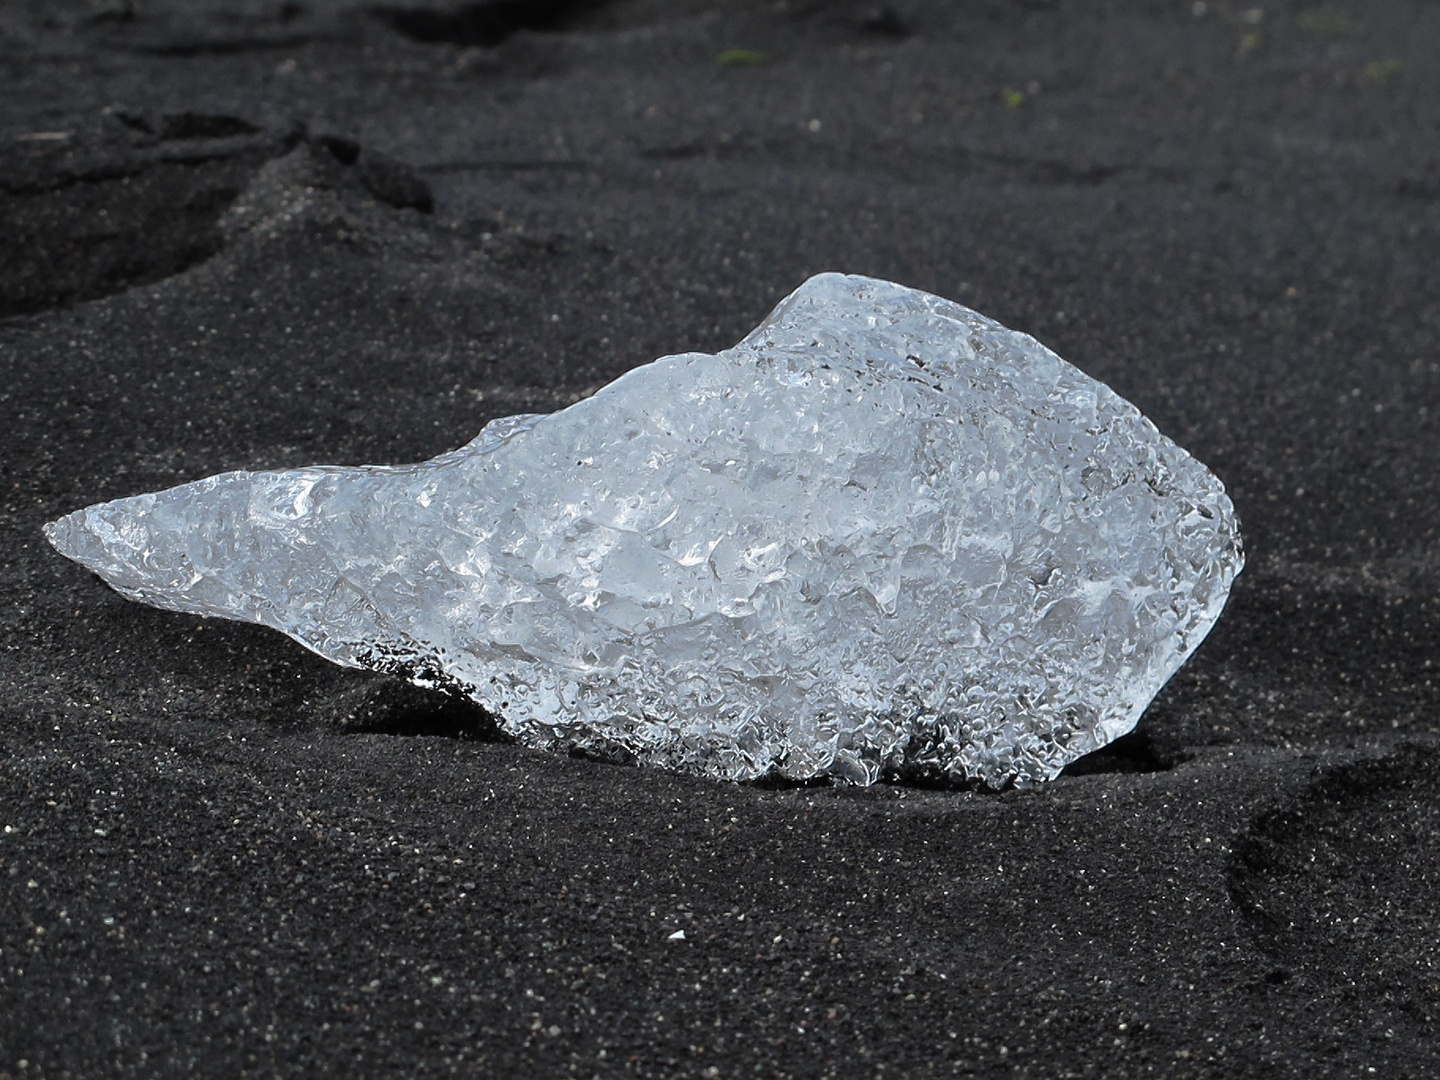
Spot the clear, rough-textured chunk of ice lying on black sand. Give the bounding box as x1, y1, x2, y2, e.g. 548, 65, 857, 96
46, 274, 1243, 786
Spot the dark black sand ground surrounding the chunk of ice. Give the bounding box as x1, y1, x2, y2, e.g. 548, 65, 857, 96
0, 0, 1440, 1079
